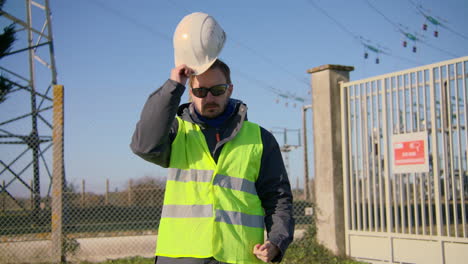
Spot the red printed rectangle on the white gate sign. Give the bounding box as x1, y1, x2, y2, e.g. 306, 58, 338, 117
393, 140, 426, 165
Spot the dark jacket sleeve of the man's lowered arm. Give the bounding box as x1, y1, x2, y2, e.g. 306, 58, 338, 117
256, 128, 294, 262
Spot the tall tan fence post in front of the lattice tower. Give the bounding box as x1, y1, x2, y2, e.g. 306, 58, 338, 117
51, 85, 66, 263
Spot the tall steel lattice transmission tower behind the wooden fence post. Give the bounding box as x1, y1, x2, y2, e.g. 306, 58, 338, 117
0, 0, 57, 217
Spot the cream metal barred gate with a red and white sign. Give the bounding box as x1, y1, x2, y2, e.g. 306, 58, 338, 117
341, 57, 468, 264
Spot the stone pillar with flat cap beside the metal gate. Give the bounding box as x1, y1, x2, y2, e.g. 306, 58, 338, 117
307, 65, 354, 255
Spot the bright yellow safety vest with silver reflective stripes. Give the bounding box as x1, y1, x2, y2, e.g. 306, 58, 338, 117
156, 117, 264, 264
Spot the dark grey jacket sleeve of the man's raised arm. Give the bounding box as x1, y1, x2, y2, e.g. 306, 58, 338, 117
130, 80, 185, 168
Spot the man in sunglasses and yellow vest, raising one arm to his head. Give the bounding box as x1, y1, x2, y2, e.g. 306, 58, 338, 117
131, 59, 294, 264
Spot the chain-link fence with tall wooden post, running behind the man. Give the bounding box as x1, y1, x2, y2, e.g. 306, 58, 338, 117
0, 66, 312, 263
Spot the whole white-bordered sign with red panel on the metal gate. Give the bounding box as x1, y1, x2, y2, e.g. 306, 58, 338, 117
392, 131, 429, 173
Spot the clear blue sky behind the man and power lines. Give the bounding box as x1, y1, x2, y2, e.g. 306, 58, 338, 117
0, 0, 468, 192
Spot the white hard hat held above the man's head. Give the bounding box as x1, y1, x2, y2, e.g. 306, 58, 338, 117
174, 12, 226, 75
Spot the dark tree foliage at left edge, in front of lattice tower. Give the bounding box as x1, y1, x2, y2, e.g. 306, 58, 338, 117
0, 0, 16, 103
